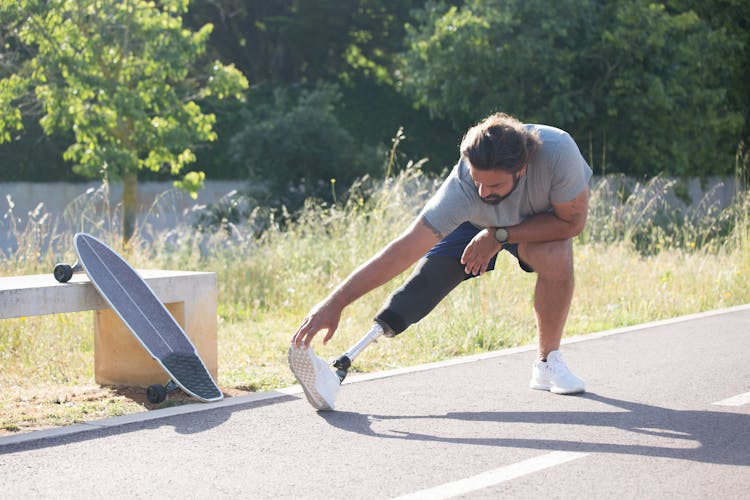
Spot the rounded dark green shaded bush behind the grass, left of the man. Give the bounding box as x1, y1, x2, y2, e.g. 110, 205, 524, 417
231, 83, 381, 208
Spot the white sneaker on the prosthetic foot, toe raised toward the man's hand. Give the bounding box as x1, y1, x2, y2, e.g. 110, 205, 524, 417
288, 345, 341, 410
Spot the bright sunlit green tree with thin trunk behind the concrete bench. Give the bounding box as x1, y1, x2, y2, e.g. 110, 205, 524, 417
0, 0, 248, 239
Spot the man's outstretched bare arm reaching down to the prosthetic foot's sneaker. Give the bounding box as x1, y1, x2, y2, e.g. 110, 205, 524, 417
292, 218, 441, 347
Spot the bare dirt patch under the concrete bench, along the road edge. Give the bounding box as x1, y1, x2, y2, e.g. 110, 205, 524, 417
0, 385, 256, 436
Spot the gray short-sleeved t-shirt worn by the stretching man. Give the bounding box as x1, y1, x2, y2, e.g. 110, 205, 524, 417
420, 125, 592, 236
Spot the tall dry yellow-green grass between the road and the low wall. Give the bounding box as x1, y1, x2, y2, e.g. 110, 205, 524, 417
0, 166, 750, 433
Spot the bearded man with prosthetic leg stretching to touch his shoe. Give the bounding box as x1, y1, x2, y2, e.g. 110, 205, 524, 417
289, 113, 592, 409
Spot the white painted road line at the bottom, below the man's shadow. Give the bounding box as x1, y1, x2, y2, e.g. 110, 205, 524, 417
394, 451, 587, 500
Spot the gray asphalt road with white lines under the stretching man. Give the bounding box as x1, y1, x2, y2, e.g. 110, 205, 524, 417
0, 306, 750, 499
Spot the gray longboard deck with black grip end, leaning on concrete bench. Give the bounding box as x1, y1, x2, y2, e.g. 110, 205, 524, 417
73, 233, 224, 401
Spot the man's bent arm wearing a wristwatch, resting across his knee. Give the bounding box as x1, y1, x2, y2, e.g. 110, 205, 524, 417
461, 187, 589, 274
